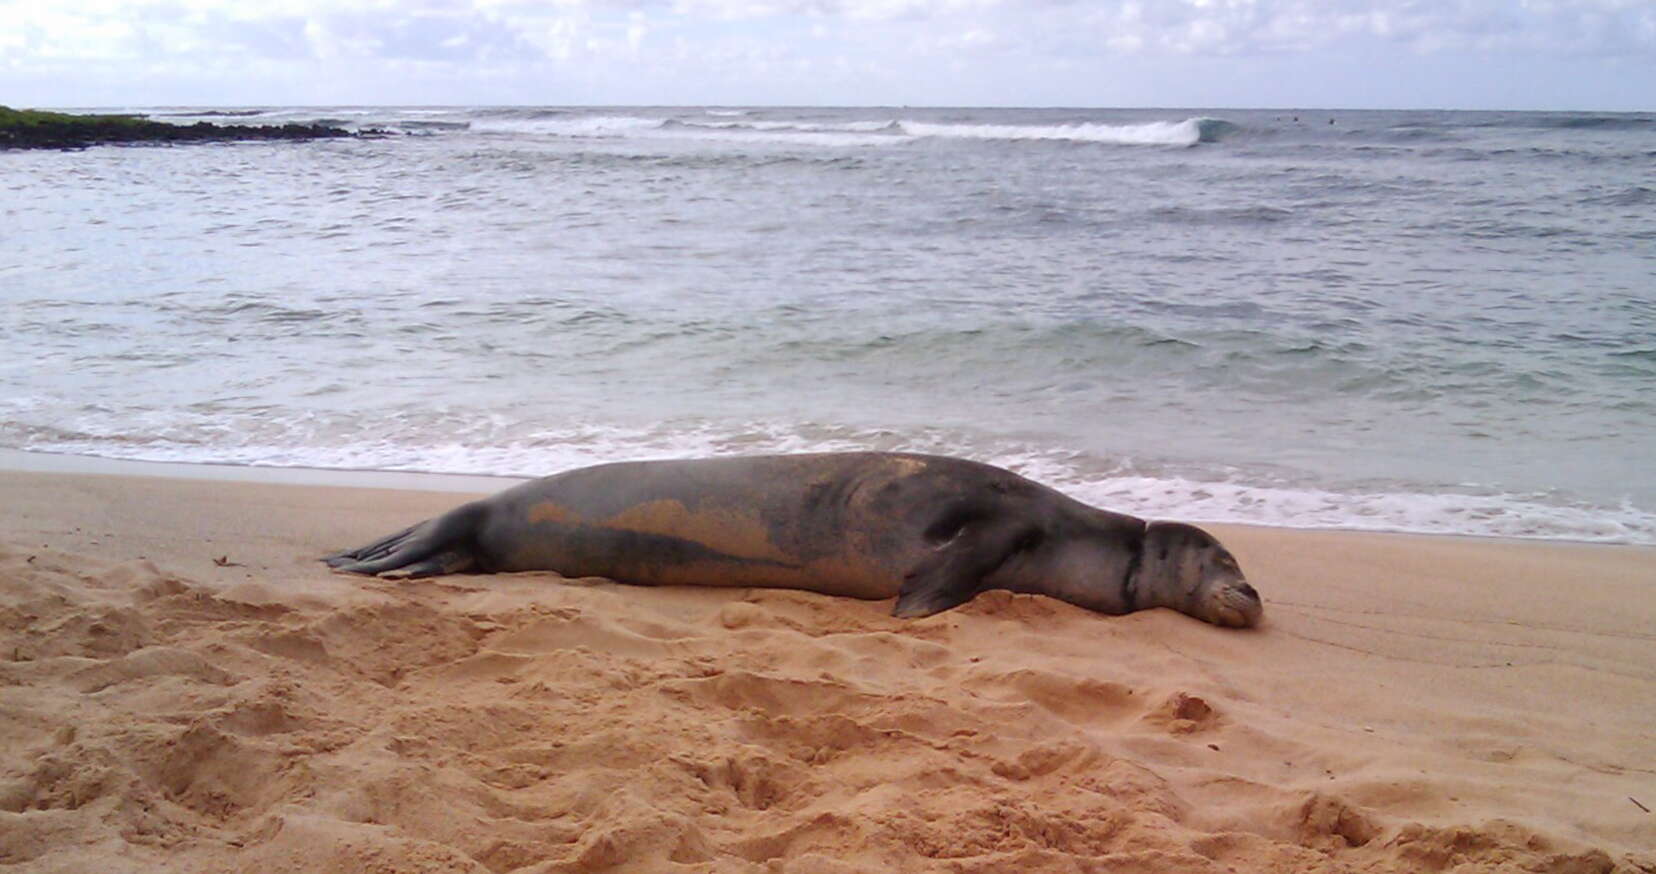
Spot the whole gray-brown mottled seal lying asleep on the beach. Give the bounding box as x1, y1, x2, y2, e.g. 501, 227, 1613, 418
323, 452, 1264, 627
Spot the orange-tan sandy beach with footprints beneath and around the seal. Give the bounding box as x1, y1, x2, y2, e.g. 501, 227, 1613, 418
0, 472, 1656, 874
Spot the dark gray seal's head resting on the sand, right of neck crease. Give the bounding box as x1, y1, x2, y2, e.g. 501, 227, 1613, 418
1131, 521, 1265, 627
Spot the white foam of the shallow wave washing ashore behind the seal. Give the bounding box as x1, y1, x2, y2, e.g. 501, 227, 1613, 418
7, 417, 1656, 545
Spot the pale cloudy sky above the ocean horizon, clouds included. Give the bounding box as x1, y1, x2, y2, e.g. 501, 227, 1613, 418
0, 0, 1656, 111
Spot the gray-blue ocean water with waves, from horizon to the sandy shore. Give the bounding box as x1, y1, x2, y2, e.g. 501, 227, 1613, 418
0, 108, 1656, 545
